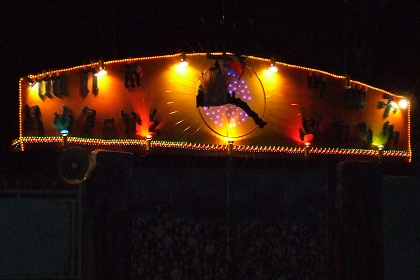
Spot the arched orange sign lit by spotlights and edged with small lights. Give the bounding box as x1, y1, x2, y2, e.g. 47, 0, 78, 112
13, 53, 411, 161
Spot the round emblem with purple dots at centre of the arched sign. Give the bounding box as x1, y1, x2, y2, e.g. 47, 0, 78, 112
197, 57, 267, 139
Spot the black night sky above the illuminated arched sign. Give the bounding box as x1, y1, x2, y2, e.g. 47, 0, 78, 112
0, 0, 420, 154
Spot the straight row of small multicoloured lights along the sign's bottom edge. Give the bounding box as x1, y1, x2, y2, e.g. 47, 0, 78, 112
12, 136, 410, 157
